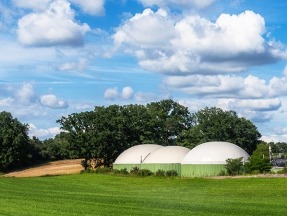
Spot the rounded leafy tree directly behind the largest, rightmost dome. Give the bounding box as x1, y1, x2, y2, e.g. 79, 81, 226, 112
180, 107, 261, 154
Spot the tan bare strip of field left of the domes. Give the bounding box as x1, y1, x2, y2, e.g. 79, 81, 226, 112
4, 159, 83, 177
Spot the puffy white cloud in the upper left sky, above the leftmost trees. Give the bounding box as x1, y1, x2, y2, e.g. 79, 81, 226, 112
18, 0, 90, 46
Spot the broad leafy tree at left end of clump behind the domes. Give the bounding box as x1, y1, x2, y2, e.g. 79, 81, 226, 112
58, 105, 133, 165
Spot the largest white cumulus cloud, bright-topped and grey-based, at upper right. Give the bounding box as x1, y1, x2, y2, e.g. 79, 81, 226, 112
113, 9, 287, 75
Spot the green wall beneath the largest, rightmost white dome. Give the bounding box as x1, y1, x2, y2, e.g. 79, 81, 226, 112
181, 164, 226, 177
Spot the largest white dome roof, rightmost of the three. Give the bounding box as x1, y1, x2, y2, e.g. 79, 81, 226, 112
181, 142, 249, 164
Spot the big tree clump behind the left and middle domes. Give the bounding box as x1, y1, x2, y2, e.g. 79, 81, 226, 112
57, 100, 192, 166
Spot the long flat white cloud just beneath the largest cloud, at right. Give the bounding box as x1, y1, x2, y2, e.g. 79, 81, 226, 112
164, 75, 287, 99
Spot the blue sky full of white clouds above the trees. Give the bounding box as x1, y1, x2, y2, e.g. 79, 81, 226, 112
0, 0, 287, 142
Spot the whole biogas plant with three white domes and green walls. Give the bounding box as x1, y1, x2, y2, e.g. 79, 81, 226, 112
113, 141, 249, 177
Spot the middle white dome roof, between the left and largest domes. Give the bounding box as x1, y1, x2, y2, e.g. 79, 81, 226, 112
143, 146, 190, 164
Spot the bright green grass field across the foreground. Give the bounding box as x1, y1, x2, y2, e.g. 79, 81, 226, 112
0, 174, 287, 216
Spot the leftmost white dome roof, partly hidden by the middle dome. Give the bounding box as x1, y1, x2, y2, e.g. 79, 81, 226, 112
114, 144, 163, 164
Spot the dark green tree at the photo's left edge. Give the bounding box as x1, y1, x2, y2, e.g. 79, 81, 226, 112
0, 111, 33, 171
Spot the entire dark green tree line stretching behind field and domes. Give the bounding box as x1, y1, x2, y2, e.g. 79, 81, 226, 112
0, 100, 286, 171
